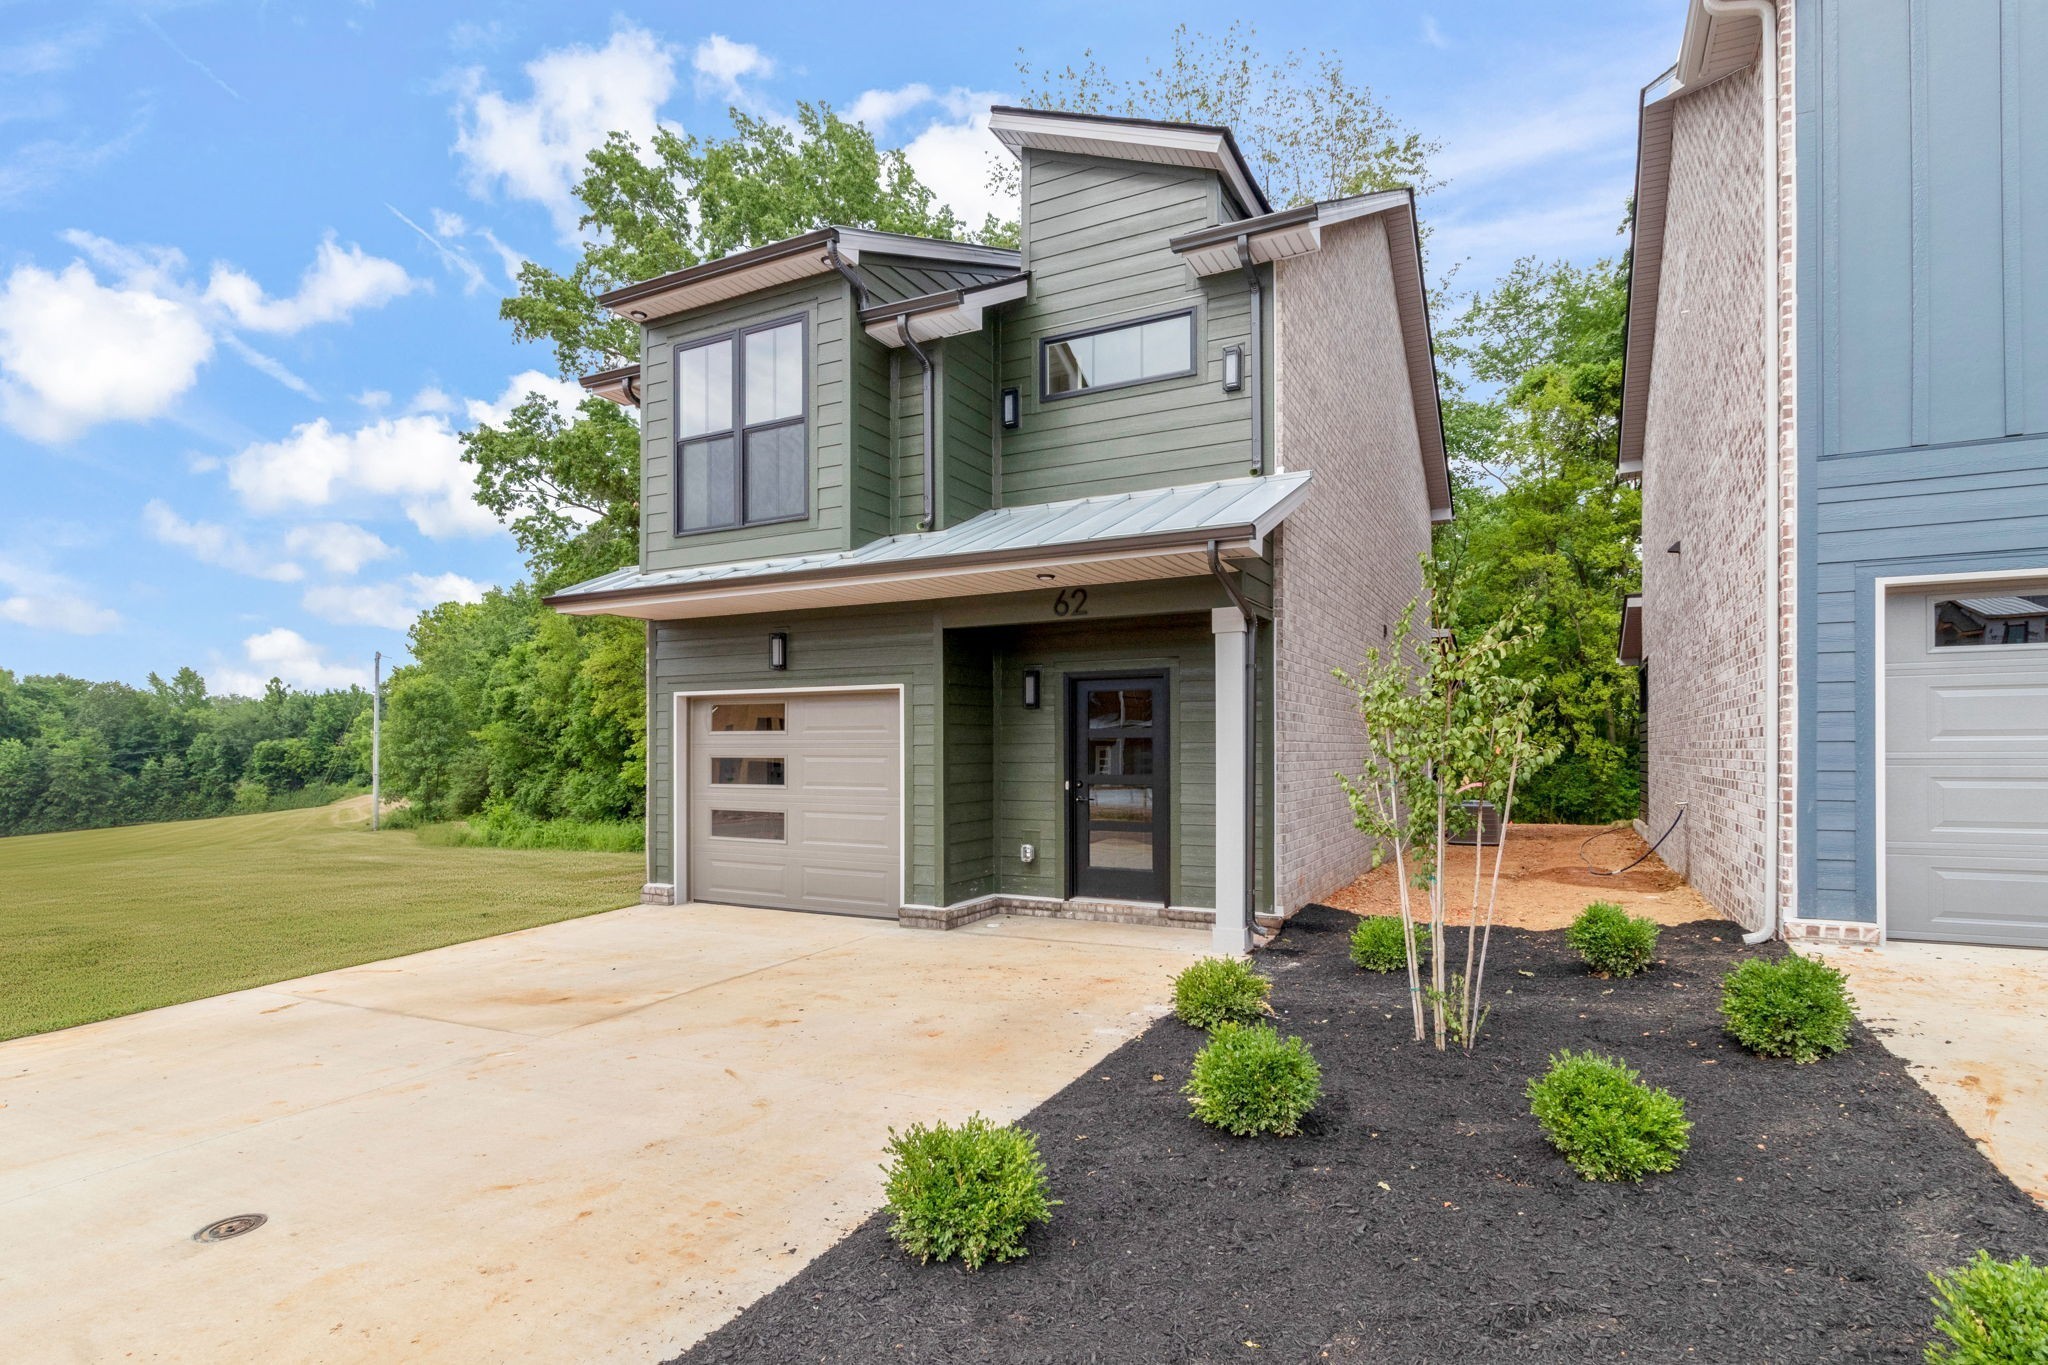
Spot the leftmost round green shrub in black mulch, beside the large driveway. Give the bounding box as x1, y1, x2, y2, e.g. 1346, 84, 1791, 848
883, 1113, 1059, 1271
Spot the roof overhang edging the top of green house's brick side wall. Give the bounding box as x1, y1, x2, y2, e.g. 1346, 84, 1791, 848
1167, 188, 1450, 522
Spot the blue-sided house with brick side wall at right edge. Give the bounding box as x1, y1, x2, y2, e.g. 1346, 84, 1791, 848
1620, 0, 2048, 945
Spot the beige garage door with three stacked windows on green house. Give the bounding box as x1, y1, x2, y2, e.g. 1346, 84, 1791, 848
684, 692, 903, 917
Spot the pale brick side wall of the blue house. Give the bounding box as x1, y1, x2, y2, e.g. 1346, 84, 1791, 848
1642, 53, 1776, 925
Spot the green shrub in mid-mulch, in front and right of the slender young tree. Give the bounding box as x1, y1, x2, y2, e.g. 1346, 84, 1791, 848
1528, 1050, 1692, 1181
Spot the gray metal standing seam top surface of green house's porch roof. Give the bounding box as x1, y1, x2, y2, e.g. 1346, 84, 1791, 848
549, 469, 1311, 602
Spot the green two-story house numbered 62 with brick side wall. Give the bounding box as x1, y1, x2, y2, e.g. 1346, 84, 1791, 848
551, 108, 1450, 952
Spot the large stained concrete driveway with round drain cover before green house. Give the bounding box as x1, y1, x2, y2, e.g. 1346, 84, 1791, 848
0, 907, 1206, 1361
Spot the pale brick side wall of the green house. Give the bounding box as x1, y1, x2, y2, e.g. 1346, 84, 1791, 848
1274, 219, 1430, 911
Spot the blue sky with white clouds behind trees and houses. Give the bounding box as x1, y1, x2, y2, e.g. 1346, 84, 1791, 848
0, 0, 1681, 692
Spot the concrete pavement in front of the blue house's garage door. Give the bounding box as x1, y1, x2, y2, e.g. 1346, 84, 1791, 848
1800, 941, 2048, 1205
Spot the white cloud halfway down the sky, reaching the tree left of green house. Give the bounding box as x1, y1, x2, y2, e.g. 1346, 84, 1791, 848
227, 370, 584, 538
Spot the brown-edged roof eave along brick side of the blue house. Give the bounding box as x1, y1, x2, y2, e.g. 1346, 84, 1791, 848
1616, 0, 1763, 479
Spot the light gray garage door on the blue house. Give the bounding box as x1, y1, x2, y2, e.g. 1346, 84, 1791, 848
1884, 581, 2048, 948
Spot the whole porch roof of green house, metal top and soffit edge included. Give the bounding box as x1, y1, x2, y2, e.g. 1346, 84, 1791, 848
547, 469, 1311, 620
